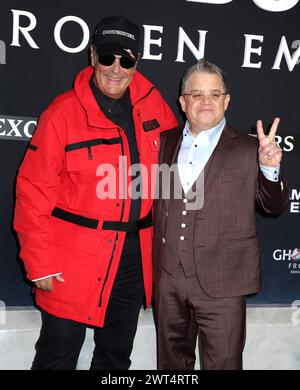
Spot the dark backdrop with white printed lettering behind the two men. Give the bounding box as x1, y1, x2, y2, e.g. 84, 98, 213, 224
0, 0, 300, 306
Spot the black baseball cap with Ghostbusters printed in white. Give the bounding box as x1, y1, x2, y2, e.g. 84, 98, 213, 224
92, 16, 141, 60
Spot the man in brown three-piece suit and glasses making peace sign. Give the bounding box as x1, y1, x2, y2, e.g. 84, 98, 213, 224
153, 59, 288, 369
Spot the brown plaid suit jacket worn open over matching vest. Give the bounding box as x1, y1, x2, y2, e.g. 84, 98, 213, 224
153, 125, 288, 297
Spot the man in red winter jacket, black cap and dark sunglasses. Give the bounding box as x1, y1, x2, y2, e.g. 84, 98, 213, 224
14, 17, 177, 370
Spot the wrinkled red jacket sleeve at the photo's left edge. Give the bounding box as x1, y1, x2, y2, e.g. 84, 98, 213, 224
14, 107, 64, 280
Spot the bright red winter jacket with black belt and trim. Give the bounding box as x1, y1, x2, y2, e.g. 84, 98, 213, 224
14, 67, 177, 326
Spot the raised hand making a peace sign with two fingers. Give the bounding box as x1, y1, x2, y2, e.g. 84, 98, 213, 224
256, 118, 282, 167
